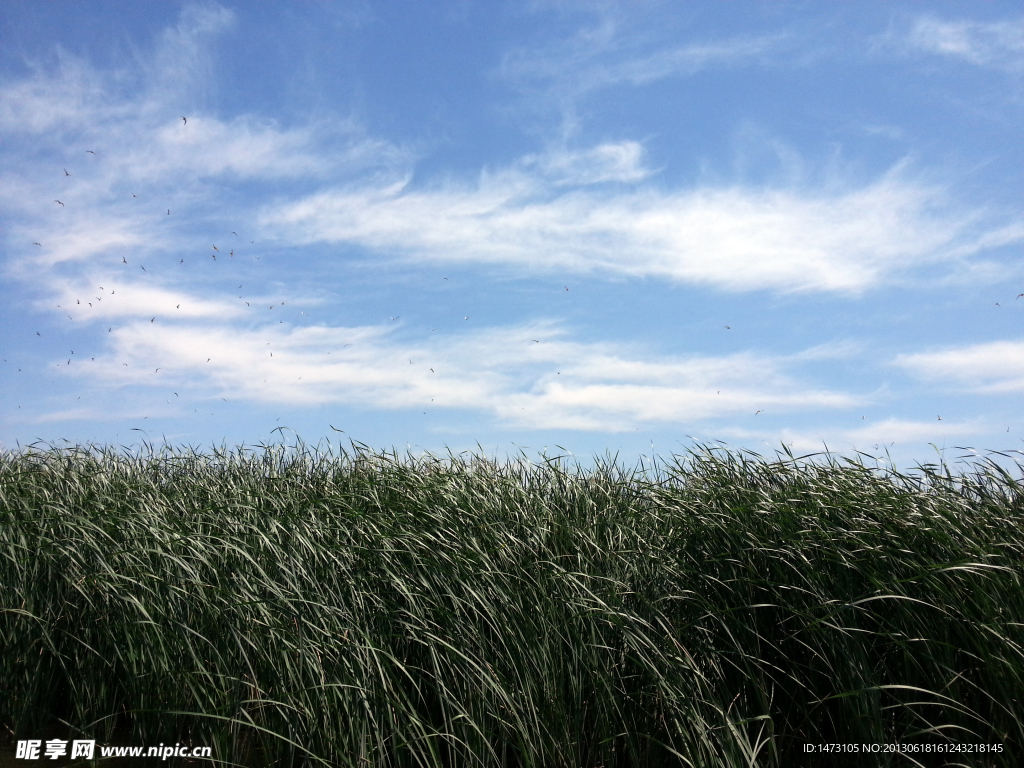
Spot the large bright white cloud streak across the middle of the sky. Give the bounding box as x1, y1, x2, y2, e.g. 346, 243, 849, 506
260, 163, 983, 292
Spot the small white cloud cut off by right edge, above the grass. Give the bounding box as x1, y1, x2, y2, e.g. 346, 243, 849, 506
894, 341, 1024, 393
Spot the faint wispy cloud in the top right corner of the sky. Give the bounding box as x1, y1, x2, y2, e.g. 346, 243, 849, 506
906, 16, 1024, 73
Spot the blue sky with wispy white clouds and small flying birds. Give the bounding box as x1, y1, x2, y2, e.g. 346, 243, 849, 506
0, 0, 1024, 467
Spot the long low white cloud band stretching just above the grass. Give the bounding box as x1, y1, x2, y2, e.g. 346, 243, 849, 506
68, 322, 860, 431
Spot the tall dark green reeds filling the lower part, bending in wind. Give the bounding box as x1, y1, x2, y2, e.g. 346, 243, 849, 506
0, 447, 1024, 768
